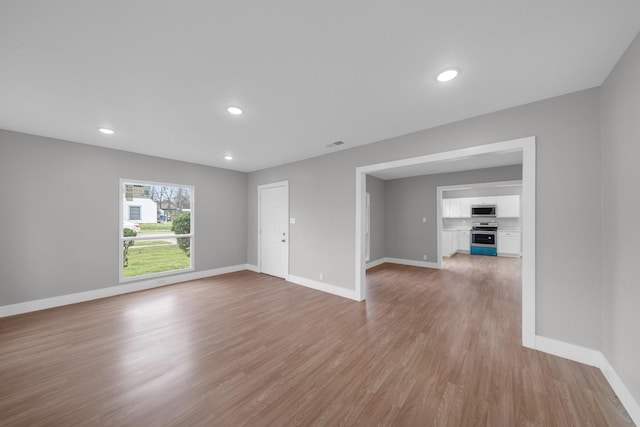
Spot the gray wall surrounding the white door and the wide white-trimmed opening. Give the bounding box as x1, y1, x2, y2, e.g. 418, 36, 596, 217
247, 89, 602, 349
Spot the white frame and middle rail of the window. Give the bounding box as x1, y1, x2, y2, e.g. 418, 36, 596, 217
118, 178, 196, 283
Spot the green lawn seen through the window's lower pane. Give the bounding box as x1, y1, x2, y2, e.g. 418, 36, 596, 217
124, 246, 190, 277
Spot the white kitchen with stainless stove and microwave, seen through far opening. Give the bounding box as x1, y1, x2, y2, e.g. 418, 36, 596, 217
441, 190, 522, 257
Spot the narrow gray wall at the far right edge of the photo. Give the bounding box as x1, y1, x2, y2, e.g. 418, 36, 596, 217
601, 32, 640, 402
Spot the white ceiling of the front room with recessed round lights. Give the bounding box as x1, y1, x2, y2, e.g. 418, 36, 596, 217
0, 0, 640, 171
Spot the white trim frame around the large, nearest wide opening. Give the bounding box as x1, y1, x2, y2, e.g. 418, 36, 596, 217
355, 136, 536, 348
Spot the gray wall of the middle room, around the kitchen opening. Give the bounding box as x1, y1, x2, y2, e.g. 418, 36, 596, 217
385, 165, 522, 262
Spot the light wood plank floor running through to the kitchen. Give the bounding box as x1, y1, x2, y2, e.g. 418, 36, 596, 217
0, 255, 632, 426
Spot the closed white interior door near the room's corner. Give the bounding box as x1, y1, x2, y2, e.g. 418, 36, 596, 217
258, 182, 289, 279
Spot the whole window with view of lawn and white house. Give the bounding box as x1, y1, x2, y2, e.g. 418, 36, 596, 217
119, 180, 194, 282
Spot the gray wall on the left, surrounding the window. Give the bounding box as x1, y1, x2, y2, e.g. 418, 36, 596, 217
0, 130, 247, 305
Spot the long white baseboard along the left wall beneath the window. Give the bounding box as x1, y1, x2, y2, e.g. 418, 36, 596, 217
0, 264, 249, 317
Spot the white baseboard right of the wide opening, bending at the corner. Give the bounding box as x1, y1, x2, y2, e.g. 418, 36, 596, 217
535, 335, 640, 426
